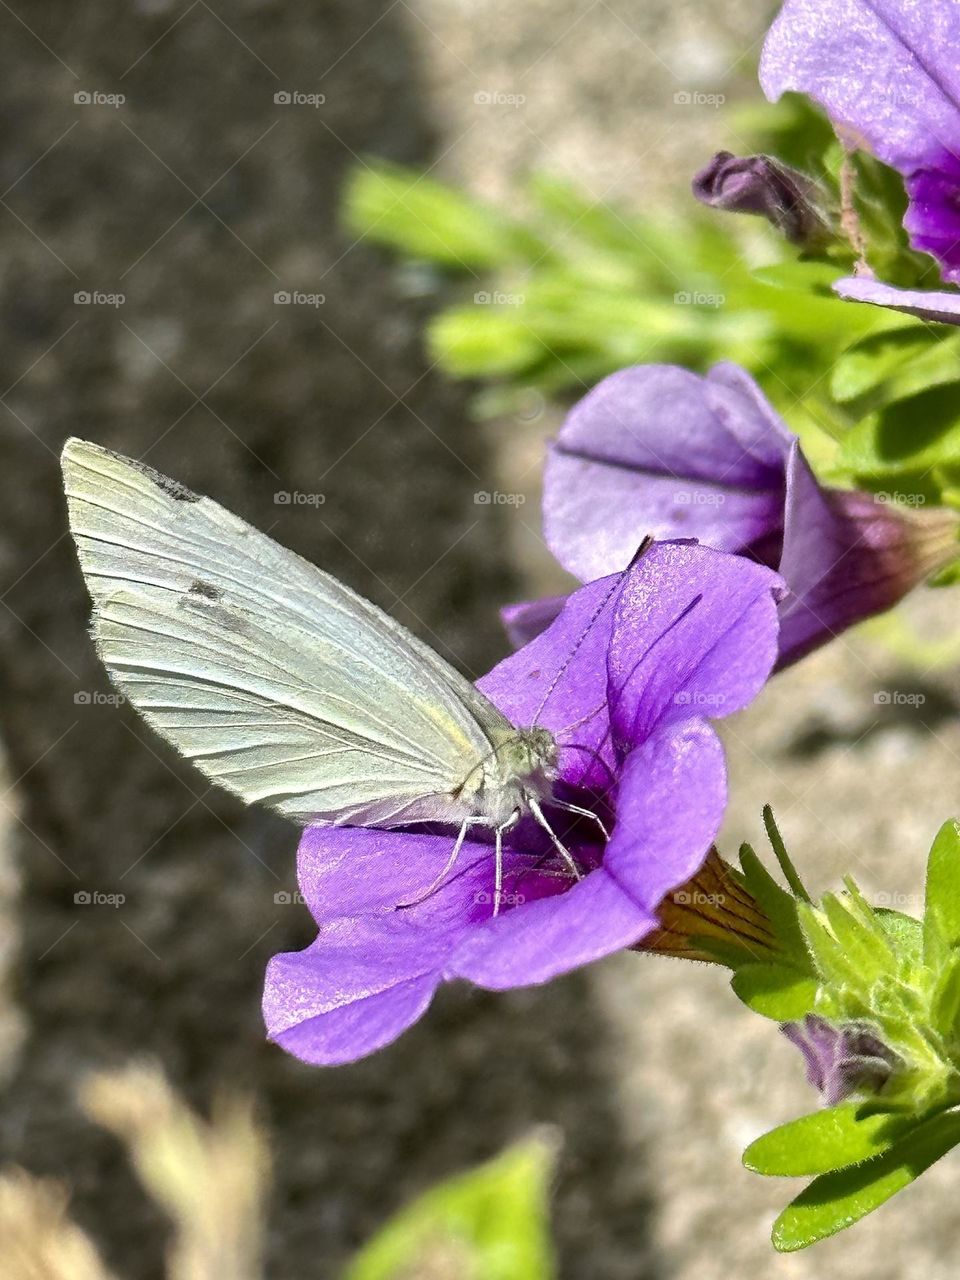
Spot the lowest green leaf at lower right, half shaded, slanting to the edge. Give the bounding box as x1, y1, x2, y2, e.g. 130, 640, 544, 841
773, 1112, 960, 1253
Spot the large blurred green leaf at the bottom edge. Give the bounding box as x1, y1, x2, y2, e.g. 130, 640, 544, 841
344, 1137, 556, 1280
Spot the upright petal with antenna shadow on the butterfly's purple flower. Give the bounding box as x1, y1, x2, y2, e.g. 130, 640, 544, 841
608, 544, 783, 750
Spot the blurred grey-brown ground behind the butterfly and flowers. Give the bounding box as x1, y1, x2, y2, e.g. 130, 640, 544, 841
0, 0, 960, 1280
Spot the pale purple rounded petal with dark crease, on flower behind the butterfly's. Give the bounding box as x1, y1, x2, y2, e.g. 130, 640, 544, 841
544, 365, 792, 581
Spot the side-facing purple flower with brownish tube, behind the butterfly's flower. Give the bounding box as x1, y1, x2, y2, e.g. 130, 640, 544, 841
504, 365, 956, 667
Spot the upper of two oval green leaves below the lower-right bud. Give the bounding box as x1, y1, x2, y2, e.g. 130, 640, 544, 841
744, 1102, 916, 1178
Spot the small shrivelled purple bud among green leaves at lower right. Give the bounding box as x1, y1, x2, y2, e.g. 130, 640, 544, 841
781, 1014, 901, 1107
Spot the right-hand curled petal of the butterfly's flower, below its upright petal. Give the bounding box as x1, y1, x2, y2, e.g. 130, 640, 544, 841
603, 719, 727, 913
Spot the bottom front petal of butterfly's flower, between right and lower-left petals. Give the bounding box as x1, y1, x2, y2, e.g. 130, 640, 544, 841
445, 868, 658, 991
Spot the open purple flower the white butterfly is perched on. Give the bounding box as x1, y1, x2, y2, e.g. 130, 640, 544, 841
264, 544, 780, 1064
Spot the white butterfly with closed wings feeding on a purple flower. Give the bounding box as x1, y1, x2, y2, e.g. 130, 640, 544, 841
63, 439, 599, 905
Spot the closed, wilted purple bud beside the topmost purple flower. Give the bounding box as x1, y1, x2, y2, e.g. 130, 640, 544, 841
692, 151, 831, 248
